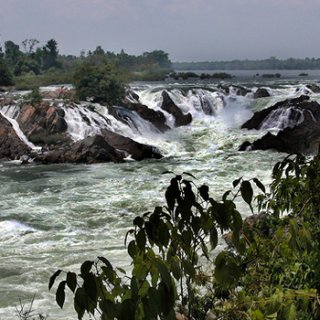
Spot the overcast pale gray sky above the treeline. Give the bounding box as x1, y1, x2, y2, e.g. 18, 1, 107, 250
0, 0, 320, 61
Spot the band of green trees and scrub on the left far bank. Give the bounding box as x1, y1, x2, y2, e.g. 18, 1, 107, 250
0, 39, 171, 89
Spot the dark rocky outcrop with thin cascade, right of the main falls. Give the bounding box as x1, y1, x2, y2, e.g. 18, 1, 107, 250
239, 95, 320, 154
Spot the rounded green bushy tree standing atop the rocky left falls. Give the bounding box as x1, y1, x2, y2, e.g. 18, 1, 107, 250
73, 56, 125, 104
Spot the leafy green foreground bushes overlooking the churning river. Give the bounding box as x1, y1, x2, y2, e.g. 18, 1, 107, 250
49, 155, 320, 320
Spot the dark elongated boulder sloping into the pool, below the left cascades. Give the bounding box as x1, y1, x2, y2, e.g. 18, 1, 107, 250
101, 129, 162, 161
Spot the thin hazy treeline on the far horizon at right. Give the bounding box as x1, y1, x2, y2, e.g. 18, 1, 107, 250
172, 57, 320, 70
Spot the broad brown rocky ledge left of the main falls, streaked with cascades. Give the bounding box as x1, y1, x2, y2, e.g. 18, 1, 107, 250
0, 90, 192, 164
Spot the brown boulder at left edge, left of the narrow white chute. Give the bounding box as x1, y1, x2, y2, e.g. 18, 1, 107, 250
0, 113, 31, 160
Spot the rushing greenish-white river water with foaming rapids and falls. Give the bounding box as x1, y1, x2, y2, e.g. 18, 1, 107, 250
0, 71, 320, 320
